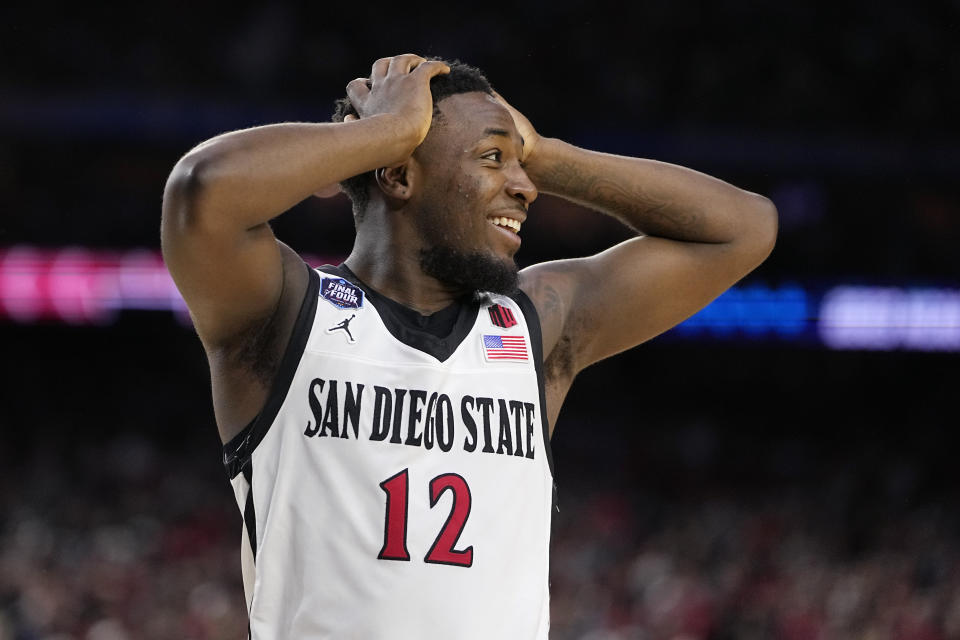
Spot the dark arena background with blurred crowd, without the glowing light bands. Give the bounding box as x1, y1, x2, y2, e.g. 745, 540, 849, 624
0, 0, 960, 640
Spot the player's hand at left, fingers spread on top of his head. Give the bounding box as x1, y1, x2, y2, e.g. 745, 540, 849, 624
344, 53, 450, 150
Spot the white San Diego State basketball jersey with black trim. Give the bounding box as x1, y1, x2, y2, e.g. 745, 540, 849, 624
224, 266, 554, 640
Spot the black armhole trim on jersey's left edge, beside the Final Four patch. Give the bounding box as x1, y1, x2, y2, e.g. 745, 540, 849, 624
223, 263, 320, 480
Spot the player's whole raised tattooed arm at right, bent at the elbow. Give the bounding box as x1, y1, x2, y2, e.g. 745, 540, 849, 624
507, 97, 777, 418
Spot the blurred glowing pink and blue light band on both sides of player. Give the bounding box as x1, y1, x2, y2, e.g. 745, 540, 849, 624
0, 246, 960, 351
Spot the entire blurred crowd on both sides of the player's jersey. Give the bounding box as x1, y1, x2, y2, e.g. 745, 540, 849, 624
0, 438, 960, 640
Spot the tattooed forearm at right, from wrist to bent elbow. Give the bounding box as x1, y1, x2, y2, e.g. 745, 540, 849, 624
526, 138, 776, 243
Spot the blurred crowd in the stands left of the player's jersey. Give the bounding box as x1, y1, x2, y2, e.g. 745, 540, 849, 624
0, 439, 247, 640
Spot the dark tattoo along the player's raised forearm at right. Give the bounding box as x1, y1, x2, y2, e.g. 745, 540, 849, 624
549, 161, 701, 239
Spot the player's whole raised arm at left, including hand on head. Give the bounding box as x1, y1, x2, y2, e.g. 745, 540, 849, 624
161, 55, 447, 349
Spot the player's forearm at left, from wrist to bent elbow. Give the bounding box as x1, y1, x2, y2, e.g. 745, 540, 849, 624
167, 115, 412, 228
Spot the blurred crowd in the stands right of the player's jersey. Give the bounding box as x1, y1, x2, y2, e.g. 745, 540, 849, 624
551, 491, 960, 640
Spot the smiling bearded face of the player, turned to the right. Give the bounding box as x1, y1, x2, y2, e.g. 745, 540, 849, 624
409, 92, 537, 293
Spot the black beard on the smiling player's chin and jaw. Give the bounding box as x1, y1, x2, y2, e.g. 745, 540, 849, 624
420, 244, 520, 295
